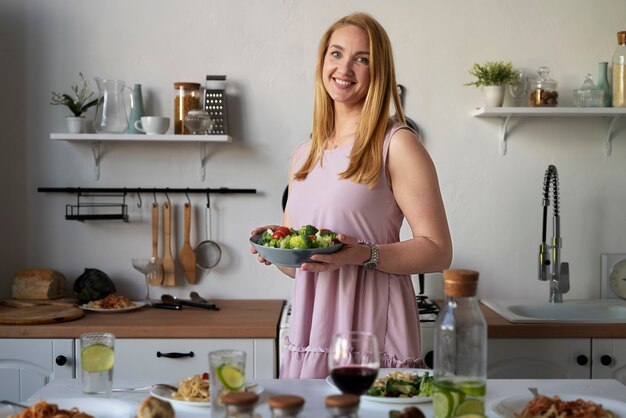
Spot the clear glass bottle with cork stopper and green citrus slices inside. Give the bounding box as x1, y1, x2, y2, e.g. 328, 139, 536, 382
433, 270, 487, 418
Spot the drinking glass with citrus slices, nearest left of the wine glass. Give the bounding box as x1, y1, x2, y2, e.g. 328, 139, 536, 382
209, 350, 246, 416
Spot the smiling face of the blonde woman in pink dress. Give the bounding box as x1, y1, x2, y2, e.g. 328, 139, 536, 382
322, 25, 370, 106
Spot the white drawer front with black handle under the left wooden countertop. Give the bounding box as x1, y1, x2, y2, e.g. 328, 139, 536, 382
76, 339, 276, 383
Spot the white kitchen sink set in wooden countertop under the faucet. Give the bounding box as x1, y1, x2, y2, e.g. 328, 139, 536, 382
481, 299, 626, 324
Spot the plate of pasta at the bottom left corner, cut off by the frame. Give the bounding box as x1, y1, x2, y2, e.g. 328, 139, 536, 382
7, 397, 137, 418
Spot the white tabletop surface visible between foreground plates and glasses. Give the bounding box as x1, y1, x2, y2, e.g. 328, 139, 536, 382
24, 379, 626, 418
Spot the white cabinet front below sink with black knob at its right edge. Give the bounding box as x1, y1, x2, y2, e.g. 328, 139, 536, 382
487, 338, 592, 379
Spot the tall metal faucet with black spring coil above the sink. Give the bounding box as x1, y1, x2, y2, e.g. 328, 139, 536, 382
539, 165, 569, 303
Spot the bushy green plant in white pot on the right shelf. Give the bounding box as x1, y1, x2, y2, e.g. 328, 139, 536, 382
465, 61, 517, 107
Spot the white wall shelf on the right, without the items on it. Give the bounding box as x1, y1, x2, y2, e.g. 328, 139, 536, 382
472, 107, 626, 156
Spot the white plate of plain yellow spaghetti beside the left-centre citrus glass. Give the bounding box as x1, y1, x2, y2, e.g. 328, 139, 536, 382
150, 373, 264, 408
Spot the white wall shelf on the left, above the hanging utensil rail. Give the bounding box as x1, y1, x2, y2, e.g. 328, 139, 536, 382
50, 133, 232, 181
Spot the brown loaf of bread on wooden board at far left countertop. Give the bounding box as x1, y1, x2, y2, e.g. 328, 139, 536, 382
12, 269, 65, 300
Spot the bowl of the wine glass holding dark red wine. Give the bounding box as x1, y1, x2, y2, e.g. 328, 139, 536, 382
328, 331, 380, 396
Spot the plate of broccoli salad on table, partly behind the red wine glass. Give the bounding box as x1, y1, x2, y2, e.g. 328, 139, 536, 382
326, 369, 433, 404
